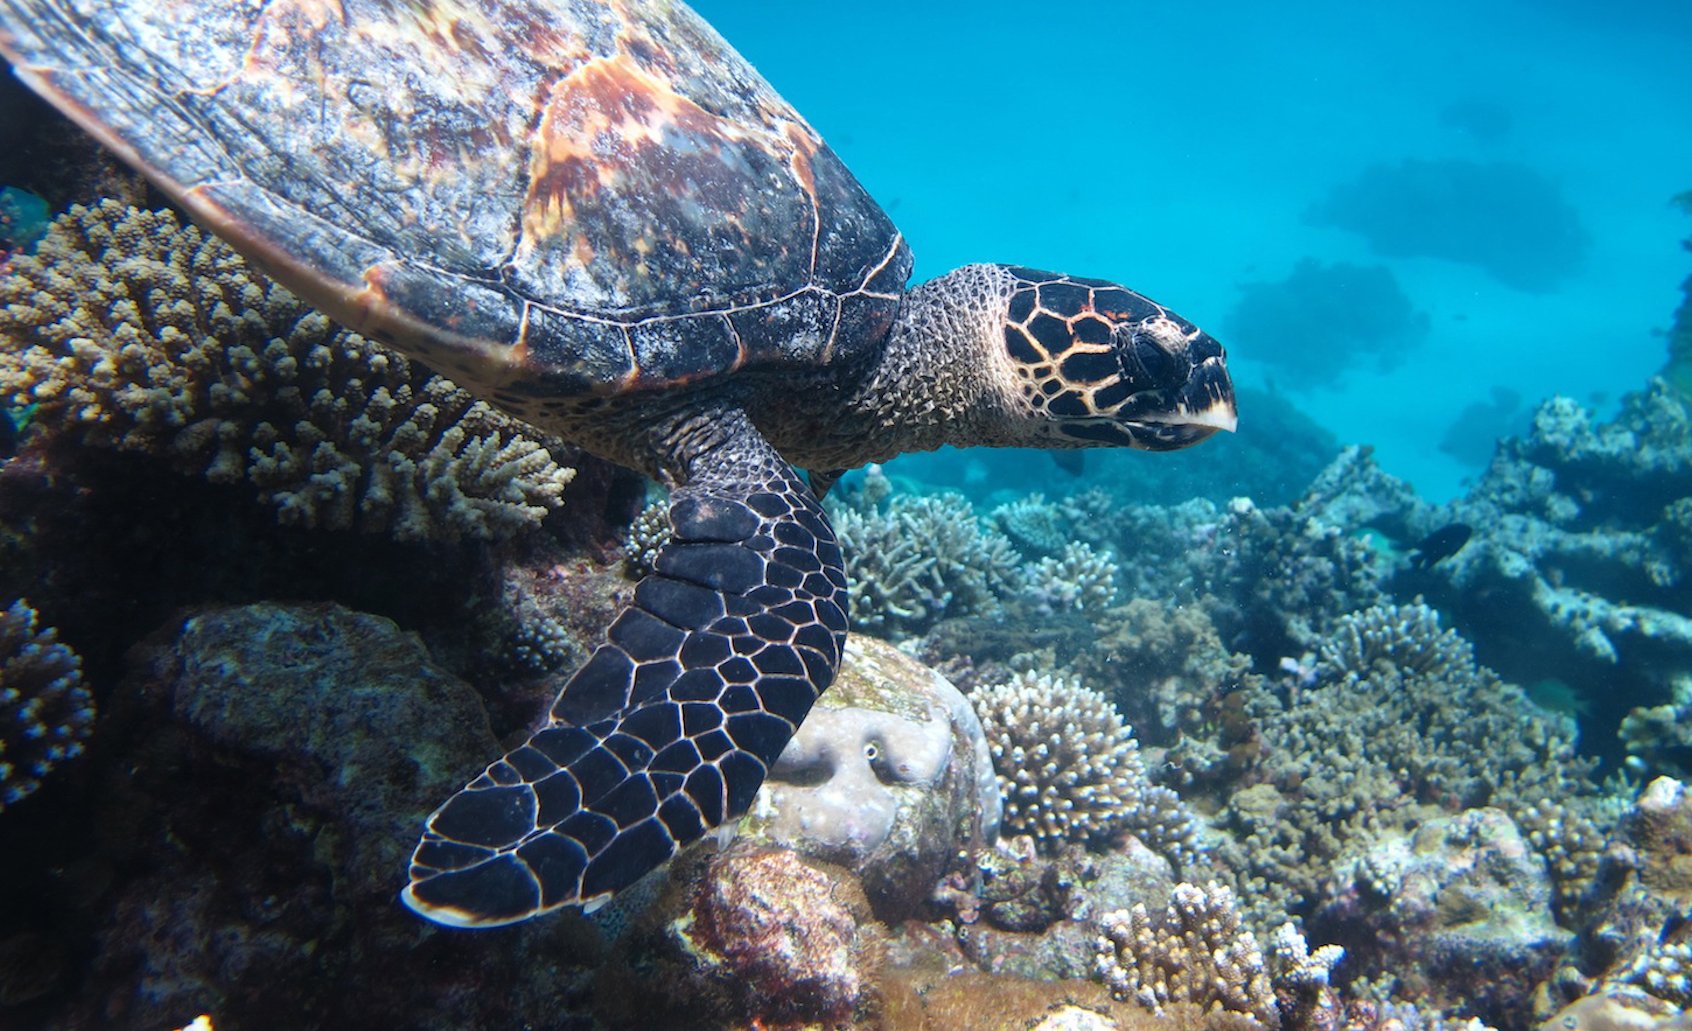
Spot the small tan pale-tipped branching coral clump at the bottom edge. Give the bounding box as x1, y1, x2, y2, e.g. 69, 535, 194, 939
1095, 884, 1279, 1029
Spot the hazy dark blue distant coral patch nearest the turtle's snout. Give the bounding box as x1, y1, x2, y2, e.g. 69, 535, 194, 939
1225, 257, 1428, 388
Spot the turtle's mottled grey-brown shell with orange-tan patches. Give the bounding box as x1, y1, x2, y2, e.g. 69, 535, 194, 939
0, 0, 910, 399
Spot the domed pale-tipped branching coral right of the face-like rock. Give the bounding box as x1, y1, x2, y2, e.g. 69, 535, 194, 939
970, 672, 1196, 863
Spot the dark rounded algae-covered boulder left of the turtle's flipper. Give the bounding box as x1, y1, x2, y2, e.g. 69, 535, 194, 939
161, 604, 497, 896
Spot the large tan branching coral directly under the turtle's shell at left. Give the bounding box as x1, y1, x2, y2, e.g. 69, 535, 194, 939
0, 201, 574, 540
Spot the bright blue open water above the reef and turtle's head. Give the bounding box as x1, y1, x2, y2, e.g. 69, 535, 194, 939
695, 0, 1692, 499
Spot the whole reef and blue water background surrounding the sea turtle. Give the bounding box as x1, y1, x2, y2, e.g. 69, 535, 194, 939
0, 0, 1692, 1031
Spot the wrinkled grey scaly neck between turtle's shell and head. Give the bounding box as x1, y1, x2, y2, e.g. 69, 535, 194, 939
798, 266, 1025, 469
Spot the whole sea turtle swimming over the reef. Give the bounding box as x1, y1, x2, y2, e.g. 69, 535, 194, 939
0, 0, 1235, 926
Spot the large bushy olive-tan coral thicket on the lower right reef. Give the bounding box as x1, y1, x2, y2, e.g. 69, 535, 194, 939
1222, 606, 1604, 924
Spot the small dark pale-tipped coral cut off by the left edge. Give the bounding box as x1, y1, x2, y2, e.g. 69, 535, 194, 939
0, 601, 95, 809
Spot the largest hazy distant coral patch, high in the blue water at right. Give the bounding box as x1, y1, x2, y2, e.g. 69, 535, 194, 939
1308, 157, 1589, 293
